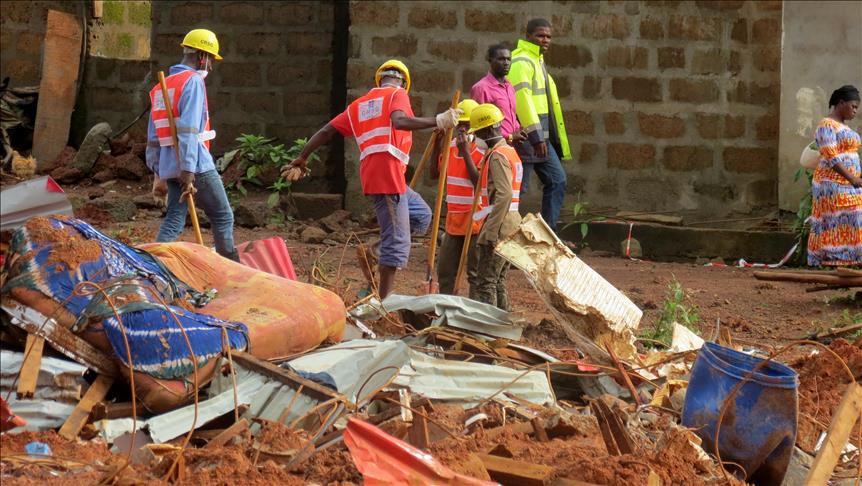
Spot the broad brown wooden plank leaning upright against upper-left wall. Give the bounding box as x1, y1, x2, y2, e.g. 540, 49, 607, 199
33, 10, 83, 168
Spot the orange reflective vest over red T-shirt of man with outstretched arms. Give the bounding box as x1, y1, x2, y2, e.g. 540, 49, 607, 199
347, 87, 413, 166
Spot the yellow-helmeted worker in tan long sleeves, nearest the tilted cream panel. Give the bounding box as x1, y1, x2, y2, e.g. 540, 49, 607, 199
470, 103, 524, 310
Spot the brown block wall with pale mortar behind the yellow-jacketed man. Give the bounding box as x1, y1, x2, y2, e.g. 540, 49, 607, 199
345, 0, 782, 217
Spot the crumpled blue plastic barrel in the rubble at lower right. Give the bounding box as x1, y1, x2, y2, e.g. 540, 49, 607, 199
682, 343, 799, 486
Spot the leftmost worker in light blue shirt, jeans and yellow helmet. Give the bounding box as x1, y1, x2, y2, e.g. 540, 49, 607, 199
146, 29, 239, 262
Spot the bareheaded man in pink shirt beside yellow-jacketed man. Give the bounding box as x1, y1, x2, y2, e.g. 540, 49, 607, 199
470, 44, 526, 145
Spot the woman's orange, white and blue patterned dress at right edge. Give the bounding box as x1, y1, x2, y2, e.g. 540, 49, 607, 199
808, 118, 862, 267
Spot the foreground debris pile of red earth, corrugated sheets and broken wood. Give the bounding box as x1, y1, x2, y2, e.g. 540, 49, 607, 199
0, 215, 862, 485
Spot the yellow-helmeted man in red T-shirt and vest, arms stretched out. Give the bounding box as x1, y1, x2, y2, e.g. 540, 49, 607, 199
282, 59, 460, 299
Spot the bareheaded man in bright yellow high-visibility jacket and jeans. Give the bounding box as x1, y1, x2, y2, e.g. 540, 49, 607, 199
509, 19, 571, 230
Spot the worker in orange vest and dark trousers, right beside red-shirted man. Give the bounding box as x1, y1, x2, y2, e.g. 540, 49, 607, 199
431, 100, 488, 298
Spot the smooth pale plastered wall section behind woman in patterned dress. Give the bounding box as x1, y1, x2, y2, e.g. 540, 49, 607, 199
778, 1, 862, 211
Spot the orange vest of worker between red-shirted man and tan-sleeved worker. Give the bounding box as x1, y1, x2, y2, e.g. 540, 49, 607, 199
446, 140, 488, 236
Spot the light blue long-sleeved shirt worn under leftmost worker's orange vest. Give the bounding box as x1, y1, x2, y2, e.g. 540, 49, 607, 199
147, 64, 215, 179
